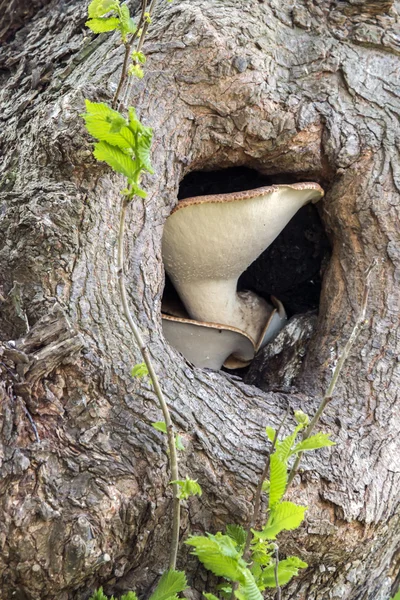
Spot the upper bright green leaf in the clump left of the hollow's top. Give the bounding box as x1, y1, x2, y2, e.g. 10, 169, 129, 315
82, 100, 136, 150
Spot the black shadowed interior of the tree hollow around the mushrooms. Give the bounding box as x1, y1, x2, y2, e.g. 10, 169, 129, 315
164, 167, 330, 377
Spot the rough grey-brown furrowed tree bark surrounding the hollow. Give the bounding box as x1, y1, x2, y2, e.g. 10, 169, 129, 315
0, 0, 400, 600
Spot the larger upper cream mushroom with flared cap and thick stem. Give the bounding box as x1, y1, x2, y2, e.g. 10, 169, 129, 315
162, 183, 324, 348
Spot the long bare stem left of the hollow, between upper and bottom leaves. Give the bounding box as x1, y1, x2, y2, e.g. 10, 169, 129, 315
118, 198, 180, 569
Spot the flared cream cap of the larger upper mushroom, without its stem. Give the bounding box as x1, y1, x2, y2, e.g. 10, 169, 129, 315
162, 183, 324, 282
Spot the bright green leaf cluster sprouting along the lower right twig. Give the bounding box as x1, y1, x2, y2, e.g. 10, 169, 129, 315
186, 411, 333, 600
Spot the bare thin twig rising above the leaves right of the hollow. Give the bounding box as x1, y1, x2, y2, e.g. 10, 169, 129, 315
286, 261, 376, 489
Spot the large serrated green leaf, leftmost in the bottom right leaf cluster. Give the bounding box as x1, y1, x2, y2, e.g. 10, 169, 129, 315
185, 532, 246, 582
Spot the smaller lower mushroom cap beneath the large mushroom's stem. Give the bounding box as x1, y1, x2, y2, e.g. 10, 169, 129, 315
162, 315, 255, 370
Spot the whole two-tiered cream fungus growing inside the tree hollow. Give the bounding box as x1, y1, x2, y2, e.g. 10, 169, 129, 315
162, 183, 324, 369
